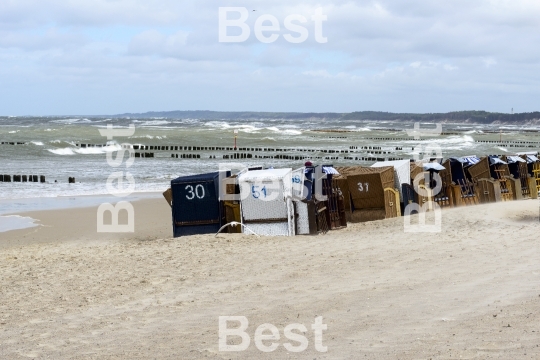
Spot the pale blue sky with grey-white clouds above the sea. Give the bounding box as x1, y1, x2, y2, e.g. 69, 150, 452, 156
0, 0, 540, 115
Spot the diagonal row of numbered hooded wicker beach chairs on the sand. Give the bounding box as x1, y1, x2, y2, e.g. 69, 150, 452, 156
164, 155, 540, 237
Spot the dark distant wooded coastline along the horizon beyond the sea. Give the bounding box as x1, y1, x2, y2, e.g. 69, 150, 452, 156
110, 110, 540, 124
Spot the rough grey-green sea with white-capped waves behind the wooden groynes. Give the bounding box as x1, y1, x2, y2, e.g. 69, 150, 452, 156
0, 117, 540, 200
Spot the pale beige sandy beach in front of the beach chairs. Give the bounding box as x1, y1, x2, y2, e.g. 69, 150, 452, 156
0, 199, 540, 359
